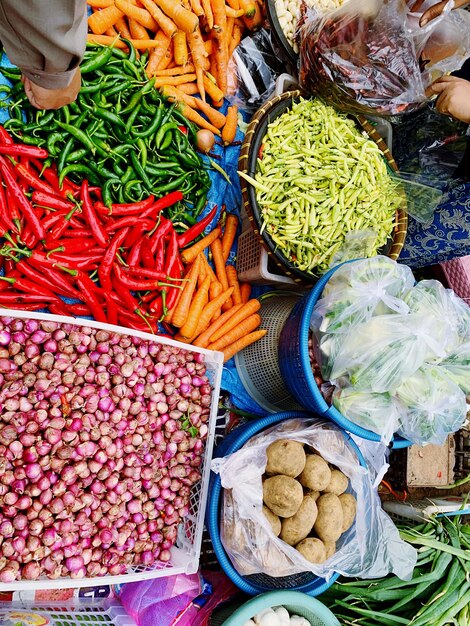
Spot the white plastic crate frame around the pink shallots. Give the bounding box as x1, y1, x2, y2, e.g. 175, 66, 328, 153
0, 309, 223, 588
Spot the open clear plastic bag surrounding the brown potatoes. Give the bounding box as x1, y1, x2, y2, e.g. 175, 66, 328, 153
211, 419, 416, 580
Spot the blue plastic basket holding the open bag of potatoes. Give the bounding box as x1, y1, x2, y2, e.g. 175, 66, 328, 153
206, 411, 367, 596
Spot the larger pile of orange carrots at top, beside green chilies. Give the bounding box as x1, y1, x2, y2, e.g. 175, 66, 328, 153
88, 0, 263, 134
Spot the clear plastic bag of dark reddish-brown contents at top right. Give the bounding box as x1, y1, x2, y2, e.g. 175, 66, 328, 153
299, 0, 466, 116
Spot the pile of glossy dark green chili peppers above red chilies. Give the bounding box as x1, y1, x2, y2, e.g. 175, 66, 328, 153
0, 42, 211, 217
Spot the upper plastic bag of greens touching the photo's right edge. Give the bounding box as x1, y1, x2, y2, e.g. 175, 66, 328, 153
405, 280, 470, 354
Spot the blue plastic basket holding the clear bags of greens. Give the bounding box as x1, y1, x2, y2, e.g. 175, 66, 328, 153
278, 261, 411, 449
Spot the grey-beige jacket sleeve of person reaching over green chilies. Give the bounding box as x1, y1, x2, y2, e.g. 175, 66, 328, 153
0, 0, 87, 89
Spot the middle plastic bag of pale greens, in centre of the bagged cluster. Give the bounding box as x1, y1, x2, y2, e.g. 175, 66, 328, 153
331, 314, 445, 393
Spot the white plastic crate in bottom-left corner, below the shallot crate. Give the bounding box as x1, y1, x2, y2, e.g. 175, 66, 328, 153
0, 598, 136, 626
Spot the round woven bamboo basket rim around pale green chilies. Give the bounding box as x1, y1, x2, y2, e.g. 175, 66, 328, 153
238, 89, 408, 285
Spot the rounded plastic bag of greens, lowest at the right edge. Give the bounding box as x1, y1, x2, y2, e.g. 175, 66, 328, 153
396, 365, 467, 445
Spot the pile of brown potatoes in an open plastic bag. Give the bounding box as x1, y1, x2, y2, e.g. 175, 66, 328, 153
263, 439, 356, 563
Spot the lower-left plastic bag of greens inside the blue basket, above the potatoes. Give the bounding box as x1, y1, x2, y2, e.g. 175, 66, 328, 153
333, 387, 403, 445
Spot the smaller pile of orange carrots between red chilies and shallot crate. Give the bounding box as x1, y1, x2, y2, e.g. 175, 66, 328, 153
165, 214, 267, 362
